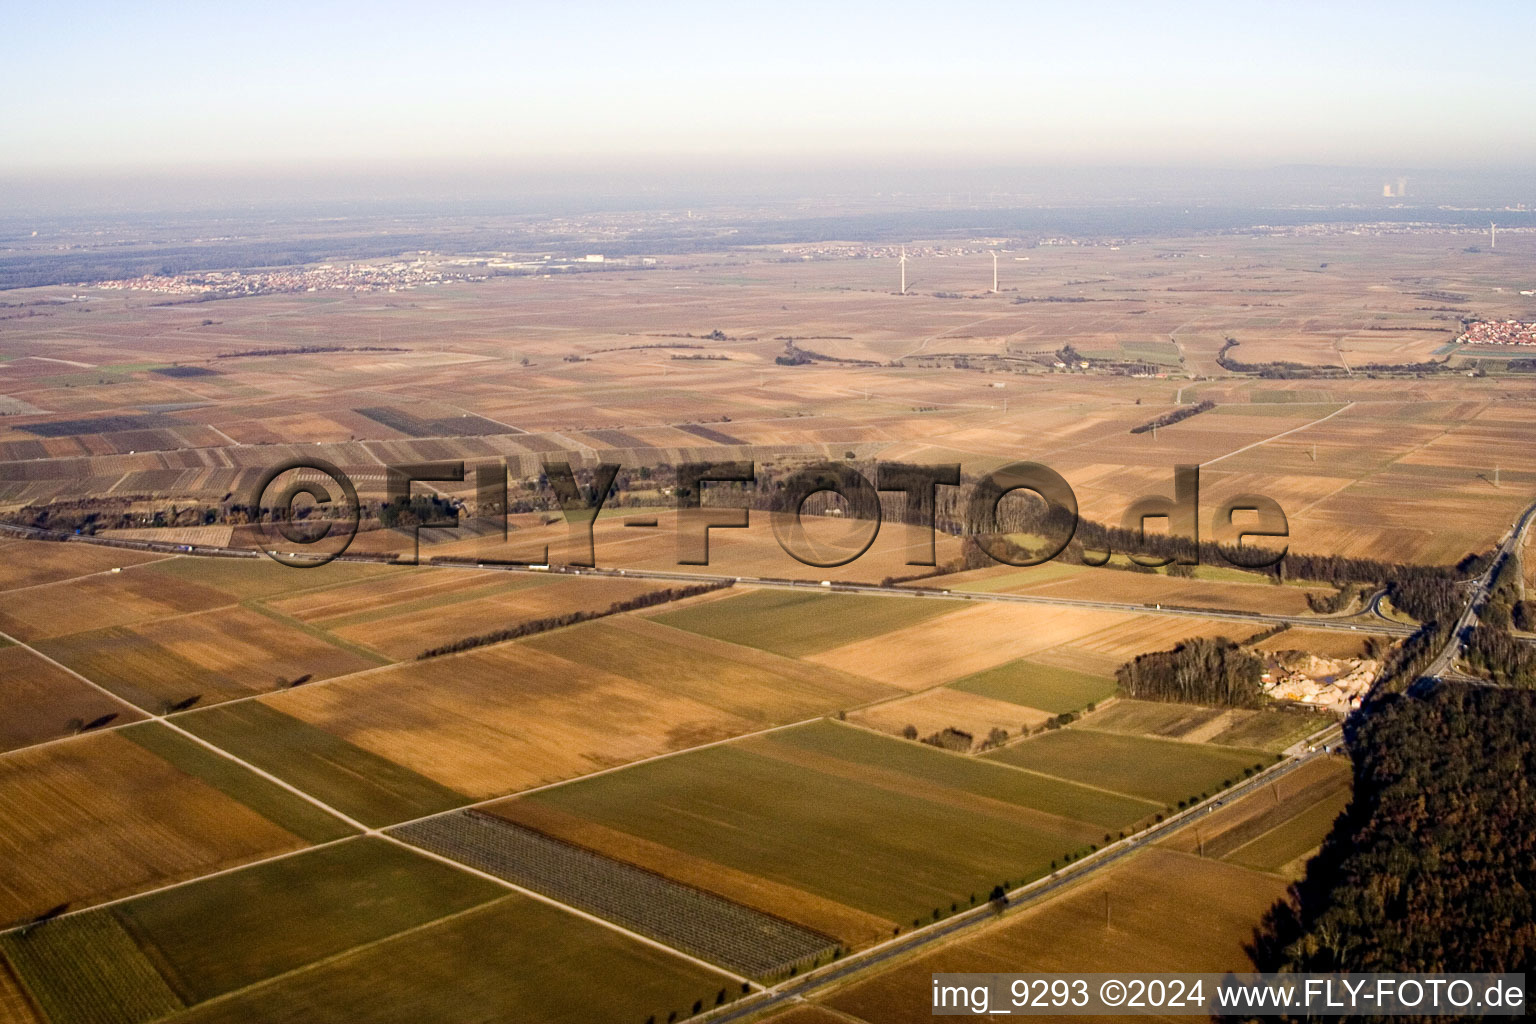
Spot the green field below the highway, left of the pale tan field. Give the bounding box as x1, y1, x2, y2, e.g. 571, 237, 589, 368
654, 590, 960, 657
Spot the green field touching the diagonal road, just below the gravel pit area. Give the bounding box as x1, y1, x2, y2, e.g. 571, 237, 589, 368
986, 729, 1275, 804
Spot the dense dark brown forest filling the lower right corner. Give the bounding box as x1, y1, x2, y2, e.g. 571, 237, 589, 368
1250, 683, 1536, 972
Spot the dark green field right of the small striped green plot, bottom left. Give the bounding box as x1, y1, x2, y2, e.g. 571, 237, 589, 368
115, 837, 507, 1003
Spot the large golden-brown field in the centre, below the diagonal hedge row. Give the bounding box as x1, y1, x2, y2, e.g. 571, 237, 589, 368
267, 616, 892, 798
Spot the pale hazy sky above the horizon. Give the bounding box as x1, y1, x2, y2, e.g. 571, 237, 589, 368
0, 0, 1536, 173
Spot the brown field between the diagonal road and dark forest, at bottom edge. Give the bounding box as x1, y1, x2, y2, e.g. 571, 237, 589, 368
825, 847, 1286, 1024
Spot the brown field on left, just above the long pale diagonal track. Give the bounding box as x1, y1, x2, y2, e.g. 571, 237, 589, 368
37, 606, 378, 712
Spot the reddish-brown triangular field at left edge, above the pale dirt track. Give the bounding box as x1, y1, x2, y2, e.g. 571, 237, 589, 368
0, 645, 144, 751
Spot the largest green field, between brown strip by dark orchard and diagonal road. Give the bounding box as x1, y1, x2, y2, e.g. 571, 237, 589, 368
527, 722, 1157, 923
